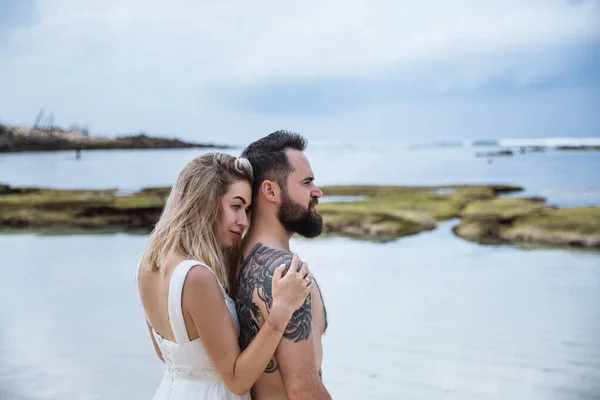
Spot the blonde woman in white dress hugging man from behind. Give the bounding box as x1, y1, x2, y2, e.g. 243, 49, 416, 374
138, 153, 312, 400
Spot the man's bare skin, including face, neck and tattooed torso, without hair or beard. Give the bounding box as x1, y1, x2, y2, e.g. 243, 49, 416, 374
234, 150, 331, 400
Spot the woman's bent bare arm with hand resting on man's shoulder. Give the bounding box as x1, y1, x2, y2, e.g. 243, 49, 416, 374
182, 261, 312, 395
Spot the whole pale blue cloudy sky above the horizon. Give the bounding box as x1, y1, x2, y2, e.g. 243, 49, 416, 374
0, 0, 600, 144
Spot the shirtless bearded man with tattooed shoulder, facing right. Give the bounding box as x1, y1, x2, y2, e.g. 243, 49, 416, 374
234, 131, 331, 400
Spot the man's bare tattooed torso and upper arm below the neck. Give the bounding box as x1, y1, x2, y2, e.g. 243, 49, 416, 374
234, 243, 330, 400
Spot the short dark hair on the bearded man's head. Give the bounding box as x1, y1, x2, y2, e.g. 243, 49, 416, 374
241, 130, 308, 197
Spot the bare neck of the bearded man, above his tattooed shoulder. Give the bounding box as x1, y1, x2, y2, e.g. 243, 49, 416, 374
244, 215, 292, 255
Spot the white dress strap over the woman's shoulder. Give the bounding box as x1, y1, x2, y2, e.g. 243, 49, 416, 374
168, 260, 223, 344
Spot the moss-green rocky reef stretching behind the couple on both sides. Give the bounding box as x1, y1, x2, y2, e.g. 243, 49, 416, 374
0, 185, 600, 249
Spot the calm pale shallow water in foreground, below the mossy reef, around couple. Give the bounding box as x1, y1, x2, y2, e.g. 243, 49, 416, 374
0, 222, 600, 400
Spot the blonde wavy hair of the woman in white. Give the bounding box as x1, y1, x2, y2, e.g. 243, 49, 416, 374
142, 153, 254, 290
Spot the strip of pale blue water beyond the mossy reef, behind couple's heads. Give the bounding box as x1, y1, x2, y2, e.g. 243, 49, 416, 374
0, 146, 600, 206
